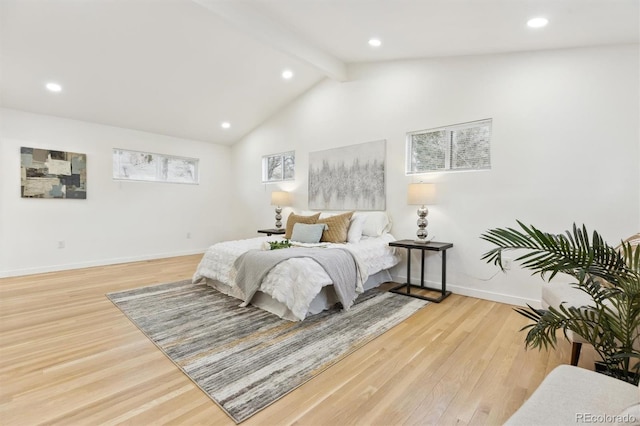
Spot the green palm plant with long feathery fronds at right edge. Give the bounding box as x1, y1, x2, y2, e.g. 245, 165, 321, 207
480, 221, 640, 384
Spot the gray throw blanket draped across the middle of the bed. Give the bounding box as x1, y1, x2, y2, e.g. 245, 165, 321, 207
233, 247, 359, 309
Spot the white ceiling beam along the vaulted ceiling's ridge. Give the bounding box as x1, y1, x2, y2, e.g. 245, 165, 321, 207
192, 0, 347, 81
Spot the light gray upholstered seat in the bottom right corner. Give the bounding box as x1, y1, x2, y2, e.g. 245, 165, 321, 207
505, 365, 640, 426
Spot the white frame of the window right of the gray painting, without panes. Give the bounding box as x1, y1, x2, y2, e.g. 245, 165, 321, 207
405, 118, 493, 175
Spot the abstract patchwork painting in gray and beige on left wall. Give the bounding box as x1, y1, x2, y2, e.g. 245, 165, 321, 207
20, 147, 87, 200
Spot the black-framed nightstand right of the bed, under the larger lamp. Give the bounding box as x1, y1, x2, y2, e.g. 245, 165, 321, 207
389, 240, 453, 303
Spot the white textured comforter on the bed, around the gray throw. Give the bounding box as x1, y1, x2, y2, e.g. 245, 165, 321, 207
193, 234, 400, 319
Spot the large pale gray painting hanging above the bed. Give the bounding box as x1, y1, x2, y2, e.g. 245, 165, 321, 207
309, 140, 386, 210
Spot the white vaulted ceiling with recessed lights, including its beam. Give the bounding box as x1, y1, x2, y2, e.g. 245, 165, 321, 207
0, 0, 640, 144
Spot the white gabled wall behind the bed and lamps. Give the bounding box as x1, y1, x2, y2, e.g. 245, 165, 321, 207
232, 45, 640, 303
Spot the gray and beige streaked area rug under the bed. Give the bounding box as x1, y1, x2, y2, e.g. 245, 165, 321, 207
107, 280, 428, 423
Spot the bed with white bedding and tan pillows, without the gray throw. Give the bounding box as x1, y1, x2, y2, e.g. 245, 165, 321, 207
192, 212, 400, 321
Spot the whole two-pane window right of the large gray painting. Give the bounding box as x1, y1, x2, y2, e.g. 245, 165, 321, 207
406, 119, 492, 174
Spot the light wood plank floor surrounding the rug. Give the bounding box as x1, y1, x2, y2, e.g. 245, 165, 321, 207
0, 255, 595, 425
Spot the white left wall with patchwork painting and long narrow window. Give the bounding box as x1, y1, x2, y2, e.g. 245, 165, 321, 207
0, 109, 232, 276
